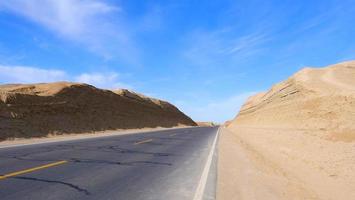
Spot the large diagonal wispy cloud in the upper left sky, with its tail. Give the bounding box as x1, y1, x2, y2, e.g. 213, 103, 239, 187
0, 0, 138, 63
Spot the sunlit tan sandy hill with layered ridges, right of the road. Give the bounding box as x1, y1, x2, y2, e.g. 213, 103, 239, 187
233, 61, 355, 139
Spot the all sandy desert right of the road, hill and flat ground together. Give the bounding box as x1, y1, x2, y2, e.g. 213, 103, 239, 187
217, 61, 355, 200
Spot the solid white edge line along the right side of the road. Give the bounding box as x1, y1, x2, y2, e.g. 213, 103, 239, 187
193, 127, 220, 200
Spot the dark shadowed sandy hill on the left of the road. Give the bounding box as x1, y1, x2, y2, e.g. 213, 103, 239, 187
0, 82, 196, 140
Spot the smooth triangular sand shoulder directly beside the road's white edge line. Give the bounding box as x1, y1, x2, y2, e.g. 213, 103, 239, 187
217, 128, 313, 200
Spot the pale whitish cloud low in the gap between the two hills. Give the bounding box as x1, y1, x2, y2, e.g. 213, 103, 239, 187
175, 92, 256, 123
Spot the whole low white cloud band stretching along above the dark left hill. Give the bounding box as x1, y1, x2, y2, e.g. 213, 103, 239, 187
0, 65, 133, 89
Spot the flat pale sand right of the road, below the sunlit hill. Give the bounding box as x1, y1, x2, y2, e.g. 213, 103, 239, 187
217, 126, 355, 200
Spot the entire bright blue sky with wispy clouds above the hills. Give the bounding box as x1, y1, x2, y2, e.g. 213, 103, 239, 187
0, 0, 355, 122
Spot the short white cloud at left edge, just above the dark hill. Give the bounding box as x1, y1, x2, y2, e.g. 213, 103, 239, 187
0, 65, 67, 83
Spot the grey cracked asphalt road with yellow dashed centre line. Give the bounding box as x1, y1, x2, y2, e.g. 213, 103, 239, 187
0, 127, 218, 200
